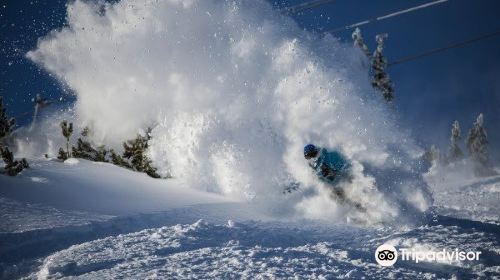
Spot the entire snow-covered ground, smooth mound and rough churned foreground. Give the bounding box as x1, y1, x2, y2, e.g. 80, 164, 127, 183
0, 160, 500, 279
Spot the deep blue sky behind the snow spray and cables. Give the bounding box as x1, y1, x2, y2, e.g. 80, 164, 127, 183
0, 0, 500, 159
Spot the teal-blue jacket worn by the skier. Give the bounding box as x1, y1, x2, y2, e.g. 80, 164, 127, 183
309, 148, 351, 185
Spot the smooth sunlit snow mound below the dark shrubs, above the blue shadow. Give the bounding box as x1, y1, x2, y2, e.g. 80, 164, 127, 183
0, 159, 232, 215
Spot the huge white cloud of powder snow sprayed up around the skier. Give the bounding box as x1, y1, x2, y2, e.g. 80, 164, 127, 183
23, 0, 431, 222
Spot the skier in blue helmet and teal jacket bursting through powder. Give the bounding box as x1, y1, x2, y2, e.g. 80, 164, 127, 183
304, 144, 351, 201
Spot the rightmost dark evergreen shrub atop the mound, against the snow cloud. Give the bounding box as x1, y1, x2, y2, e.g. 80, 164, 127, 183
123, 129, 161, 178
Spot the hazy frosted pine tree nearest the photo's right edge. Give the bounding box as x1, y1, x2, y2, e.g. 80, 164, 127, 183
466, 113, 488, 167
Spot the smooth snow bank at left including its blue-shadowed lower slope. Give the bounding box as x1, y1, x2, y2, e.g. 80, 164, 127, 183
0, 159, 252, 278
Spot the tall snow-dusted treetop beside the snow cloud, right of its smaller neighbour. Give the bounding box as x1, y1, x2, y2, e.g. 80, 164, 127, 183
372, 34, 394, 102
